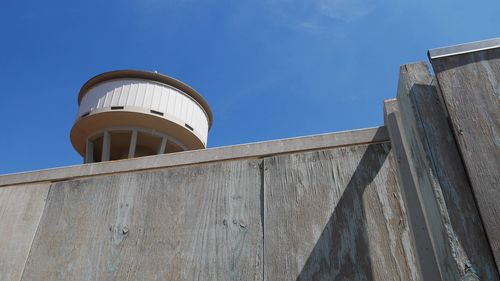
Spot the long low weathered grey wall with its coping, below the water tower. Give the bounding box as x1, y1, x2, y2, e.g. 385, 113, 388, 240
0, 127, 421, 280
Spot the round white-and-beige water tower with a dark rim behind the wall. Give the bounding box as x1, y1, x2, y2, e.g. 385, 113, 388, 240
71, 70, 212, 163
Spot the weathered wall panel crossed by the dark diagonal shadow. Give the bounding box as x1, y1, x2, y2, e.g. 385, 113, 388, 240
264, 143, 422, 280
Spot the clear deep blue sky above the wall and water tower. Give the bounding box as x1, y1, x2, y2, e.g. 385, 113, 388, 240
0, 0, 500, 174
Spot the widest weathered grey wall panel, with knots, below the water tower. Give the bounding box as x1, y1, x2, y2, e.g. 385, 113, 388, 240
20, 160, 263, 281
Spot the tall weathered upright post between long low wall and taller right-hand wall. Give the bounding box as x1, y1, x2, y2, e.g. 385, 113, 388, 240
386, 62, 498, 280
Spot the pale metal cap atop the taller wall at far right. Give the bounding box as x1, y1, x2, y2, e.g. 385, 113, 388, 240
427, 37, 500, 60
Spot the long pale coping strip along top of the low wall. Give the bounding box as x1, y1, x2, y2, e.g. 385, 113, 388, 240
0, 127, 389, 187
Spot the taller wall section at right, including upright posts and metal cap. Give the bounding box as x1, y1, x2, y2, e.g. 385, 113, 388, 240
385, 39, 500, 280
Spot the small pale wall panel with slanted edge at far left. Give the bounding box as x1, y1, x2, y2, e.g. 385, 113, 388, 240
0, 183, 50, 280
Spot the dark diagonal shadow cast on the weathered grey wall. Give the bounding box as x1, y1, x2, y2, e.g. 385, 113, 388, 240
297, 135, 389, 281
